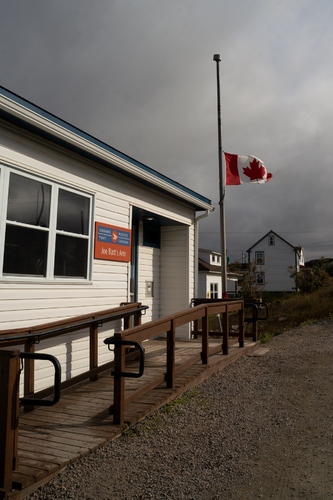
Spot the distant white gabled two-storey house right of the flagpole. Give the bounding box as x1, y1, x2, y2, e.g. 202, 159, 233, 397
247, 231, 305, 292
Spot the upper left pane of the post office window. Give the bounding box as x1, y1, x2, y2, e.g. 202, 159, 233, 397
7, 173, 51, 227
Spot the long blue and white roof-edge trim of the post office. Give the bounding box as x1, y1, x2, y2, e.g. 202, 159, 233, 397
0, 86, 211, 205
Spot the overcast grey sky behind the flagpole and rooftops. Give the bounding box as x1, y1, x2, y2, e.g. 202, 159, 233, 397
0, 0, 333, 261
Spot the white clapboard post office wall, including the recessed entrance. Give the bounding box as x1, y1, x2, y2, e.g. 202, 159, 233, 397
0, 121, 195, 389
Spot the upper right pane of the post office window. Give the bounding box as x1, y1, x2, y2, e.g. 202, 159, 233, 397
57, 189, 90, 236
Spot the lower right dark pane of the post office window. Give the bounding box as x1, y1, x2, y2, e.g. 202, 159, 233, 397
54, 234, 88, 278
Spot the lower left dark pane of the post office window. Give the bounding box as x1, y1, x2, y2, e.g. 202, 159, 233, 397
3, 225, 48, 276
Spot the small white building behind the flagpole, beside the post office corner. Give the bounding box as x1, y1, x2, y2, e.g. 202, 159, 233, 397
197, 248, 239, 299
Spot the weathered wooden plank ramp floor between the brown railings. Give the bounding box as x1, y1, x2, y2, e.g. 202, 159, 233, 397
7, 339, 259, 500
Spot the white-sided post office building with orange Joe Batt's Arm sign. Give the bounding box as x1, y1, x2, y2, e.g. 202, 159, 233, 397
0, 87, 213, 390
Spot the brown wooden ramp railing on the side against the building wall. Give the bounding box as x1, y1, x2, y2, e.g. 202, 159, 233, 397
0, 303, 147, 499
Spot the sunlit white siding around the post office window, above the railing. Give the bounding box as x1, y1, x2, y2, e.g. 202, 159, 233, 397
0, 124, 192, 329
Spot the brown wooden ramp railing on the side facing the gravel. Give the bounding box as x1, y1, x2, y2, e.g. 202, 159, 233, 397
109, 300, 244, 425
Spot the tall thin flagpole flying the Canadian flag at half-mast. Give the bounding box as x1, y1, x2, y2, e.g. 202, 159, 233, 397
213, 54, 228, 299
